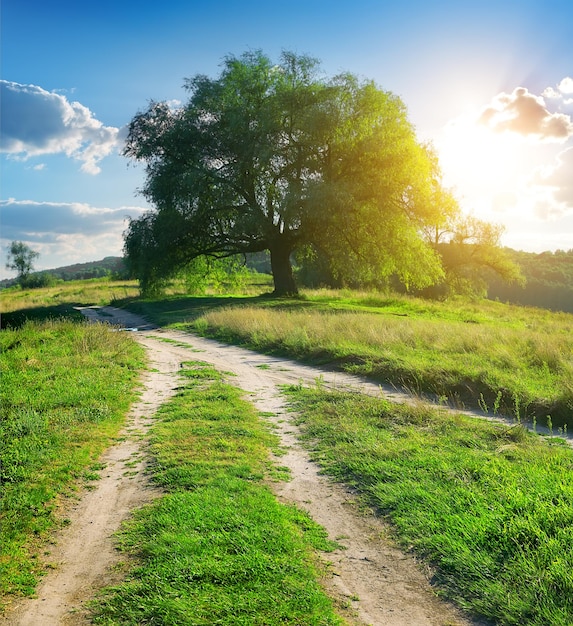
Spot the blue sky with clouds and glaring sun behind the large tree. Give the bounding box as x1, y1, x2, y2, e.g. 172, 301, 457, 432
0, 0, 573, 278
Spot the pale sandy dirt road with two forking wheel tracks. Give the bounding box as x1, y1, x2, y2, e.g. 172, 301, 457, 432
2, 307, 488, 626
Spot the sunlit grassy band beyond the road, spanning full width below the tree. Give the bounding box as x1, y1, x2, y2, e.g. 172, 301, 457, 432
7, 275, 573, 429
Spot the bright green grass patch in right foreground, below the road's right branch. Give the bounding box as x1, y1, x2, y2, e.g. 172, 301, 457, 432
289, 387, 573, 626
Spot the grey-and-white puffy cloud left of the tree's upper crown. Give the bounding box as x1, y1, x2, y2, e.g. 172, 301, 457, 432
0, 80, 119, 174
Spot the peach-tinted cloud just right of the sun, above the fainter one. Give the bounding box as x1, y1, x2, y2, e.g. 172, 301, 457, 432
479, 86, 573, 142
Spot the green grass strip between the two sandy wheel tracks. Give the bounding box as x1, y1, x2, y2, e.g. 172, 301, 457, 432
93, 363, 344, 626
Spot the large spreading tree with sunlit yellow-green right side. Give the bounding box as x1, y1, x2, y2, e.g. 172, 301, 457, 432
124, 52, 450, 295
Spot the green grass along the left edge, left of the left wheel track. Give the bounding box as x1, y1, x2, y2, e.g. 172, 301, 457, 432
0, 321, 143, 605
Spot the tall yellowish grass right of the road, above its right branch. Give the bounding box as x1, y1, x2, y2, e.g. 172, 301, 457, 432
191, 300, 573, 427
